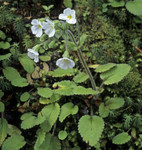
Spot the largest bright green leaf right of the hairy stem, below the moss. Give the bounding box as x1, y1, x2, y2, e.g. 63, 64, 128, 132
101, 64, 131, 85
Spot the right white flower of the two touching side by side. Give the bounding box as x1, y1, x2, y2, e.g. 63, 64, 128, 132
43, 19, 55, 37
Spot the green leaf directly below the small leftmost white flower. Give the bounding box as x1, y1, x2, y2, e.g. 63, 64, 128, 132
19, 55, 34, 74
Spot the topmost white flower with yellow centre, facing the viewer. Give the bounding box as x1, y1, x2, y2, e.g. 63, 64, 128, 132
59, 8, 76, 24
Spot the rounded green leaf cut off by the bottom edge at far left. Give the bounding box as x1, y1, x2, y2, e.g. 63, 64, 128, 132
2, 135, 26, 150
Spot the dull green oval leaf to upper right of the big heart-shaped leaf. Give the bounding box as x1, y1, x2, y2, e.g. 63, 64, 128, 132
105, 97, 124, 109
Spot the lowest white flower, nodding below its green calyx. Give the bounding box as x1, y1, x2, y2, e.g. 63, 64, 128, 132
56, 57, 75, 69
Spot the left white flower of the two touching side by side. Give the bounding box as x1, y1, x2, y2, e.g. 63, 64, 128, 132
31, 19, 43, 37
